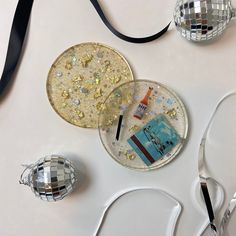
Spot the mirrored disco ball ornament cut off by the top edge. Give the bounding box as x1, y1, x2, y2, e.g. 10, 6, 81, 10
174, 0, 235, 42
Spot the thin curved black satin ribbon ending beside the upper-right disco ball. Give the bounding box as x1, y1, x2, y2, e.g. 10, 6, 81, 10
90, 0, 171, 43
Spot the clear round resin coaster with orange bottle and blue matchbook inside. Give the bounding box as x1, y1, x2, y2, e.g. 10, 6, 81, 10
99, 80, 188, 170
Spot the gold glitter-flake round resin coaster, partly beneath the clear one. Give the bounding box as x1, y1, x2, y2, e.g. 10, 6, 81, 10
47, 43, 133, 128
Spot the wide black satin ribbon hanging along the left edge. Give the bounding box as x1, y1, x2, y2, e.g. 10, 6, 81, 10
0, 0, 34, 97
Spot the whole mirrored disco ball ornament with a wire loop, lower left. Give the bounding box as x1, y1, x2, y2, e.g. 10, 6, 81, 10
20, 155, 78, 202
